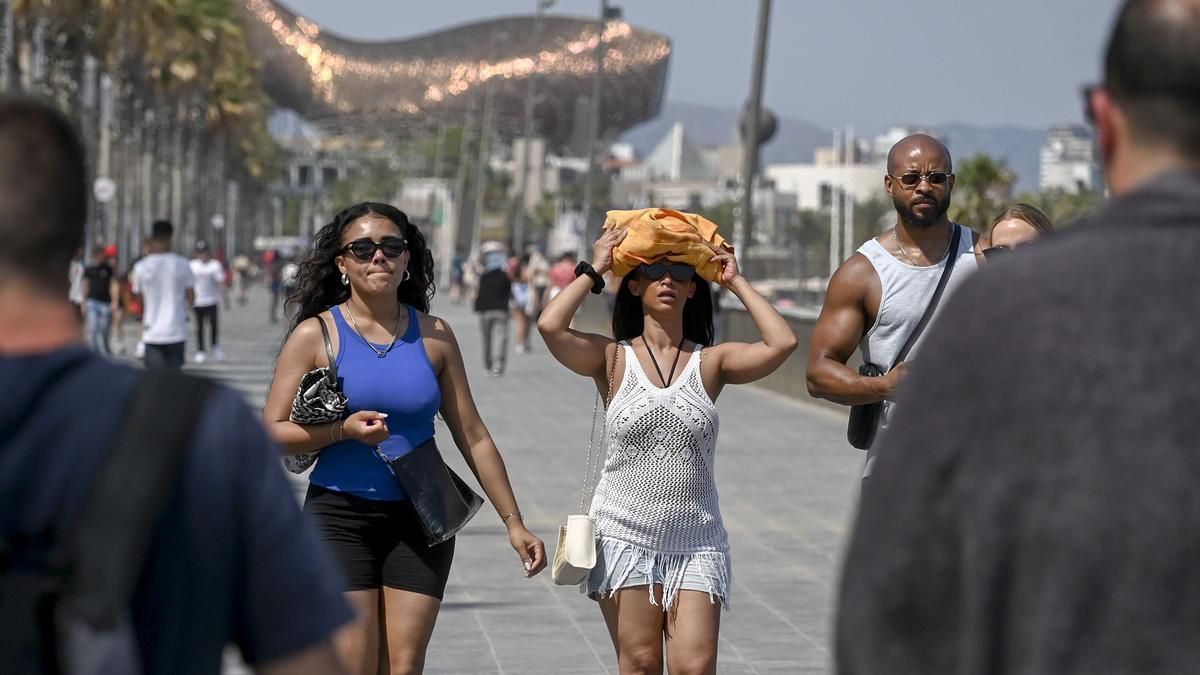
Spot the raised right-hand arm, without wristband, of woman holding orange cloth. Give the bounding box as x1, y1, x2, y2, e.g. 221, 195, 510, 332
712, 246, 796, 386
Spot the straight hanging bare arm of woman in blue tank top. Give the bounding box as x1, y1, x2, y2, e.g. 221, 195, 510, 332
422, 317, 546, 577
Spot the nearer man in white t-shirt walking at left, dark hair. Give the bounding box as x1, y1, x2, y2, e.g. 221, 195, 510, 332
130, 220, 196, 368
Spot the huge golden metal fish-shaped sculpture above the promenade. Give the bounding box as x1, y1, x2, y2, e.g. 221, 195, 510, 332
244, 0, 671, 145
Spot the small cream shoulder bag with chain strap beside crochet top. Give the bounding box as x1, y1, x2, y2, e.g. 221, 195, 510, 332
551, 342, 622, 586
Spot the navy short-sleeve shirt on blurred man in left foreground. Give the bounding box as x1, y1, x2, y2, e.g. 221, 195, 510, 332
0, 347, 352, 674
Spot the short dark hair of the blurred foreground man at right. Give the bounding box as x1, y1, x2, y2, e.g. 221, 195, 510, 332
1104, 0, 1200, 160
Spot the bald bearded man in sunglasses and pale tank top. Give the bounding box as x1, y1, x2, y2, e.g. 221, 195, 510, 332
808, 128, 979, 477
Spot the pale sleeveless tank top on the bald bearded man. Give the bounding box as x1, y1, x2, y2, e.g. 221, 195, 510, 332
858, 223, 979, 476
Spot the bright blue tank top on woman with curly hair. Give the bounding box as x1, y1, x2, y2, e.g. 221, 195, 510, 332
308, 306, 442, 501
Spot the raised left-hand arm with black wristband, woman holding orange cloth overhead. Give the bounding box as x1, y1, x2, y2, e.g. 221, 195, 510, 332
538, 229, 628, 382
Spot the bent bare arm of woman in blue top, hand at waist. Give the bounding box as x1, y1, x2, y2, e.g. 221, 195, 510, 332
263, 318, 388, 454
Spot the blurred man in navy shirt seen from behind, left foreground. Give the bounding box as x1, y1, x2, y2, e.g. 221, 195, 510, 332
0, 98, 350, 675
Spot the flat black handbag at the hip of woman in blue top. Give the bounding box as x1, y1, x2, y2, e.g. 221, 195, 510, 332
376, 438, 484, 546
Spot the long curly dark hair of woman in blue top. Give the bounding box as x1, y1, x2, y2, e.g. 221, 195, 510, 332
287, 202, 434, 329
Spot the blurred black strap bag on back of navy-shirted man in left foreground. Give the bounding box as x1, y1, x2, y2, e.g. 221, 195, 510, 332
0, 370, 212, 675
